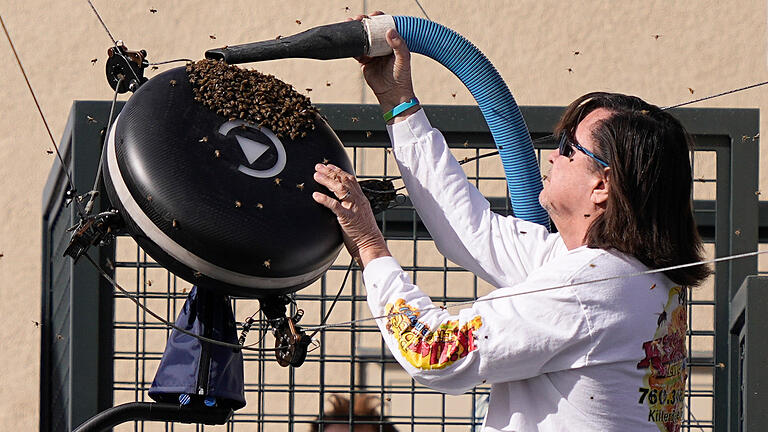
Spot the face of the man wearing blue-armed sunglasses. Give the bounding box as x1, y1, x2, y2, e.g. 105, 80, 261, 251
539, 108, 611, 224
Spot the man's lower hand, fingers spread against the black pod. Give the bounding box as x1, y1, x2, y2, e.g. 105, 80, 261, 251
312, 164, 391, 268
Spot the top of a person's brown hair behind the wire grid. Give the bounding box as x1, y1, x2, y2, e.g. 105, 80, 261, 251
310, 394, 397, 432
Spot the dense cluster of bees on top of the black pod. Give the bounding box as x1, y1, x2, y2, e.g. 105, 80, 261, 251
187, 59, 317, 140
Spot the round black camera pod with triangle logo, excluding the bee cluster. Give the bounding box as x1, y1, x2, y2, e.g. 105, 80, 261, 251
103, 67, 353, 298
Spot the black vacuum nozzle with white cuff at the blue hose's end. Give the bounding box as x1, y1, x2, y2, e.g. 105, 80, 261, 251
205, 15, 395, 64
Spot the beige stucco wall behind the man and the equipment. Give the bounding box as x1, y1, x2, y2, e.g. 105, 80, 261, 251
0, 0, 768, 430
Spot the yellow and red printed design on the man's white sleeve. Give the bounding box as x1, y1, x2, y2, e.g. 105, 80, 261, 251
385, 299, 483, 370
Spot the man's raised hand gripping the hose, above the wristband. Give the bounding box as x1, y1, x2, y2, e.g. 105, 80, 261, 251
355, 11, 418, 119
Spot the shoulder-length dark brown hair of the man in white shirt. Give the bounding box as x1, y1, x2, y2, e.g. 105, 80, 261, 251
555, 92, 710, 286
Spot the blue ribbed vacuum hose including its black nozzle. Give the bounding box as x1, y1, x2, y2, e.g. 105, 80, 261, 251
205, 15, 549, 227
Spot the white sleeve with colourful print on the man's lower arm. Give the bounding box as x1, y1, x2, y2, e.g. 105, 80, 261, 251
364, 257, 592, 394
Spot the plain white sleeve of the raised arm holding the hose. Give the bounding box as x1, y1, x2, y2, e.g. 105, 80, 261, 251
388, 110, 565, 287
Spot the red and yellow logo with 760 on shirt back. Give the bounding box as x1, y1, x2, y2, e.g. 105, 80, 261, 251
637, 287, 688, 432
